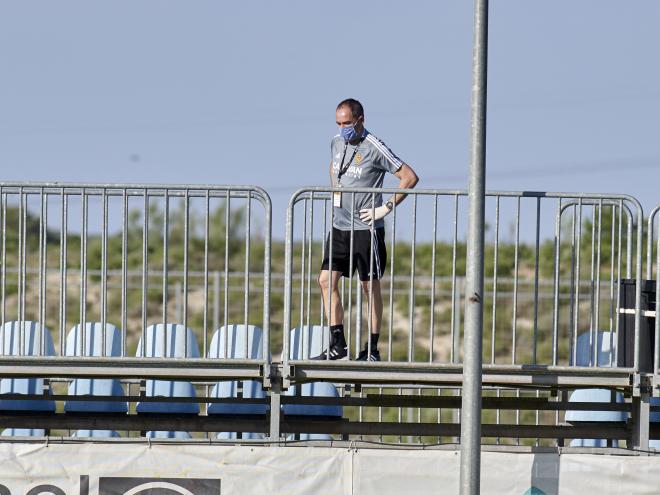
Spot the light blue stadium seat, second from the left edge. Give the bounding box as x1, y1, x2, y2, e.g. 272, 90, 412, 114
64, 322, 128, 437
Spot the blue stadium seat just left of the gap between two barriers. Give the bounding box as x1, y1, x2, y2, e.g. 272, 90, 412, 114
207, 325, 269, 440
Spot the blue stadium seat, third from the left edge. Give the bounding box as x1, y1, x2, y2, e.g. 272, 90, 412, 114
136, 323, 199, 438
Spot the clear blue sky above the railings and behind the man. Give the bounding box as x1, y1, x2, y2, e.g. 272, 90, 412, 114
0, 0, 660, 229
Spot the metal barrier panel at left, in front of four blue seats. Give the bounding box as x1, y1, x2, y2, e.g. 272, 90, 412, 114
0, 183, 271, 361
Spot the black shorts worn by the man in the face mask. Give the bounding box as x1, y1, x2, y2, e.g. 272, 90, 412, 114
321, 227, 387, 282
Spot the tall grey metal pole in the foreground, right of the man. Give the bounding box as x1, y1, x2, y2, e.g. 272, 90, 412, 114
460, 0, 488, 495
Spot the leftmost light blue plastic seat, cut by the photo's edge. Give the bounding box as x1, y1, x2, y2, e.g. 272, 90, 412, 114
0, 321, 55, 412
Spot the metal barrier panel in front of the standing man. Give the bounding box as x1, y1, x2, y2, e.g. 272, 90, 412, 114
283, 188, 643, 369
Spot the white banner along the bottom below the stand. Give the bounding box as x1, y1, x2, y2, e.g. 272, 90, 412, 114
0, 443, 660, 495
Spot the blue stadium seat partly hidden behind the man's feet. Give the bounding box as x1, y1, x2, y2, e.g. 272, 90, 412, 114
282, 325, 343, 440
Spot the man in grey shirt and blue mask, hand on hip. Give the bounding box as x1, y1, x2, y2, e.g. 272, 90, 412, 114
313, 98, 419, 361
